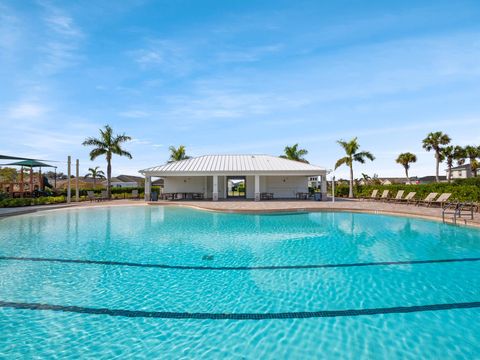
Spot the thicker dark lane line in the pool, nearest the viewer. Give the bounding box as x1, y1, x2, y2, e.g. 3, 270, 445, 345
0, 301, 480, 320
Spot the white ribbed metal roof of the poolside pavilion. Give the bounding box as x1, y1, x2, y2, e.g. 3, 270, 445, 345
139, 155, 325, 176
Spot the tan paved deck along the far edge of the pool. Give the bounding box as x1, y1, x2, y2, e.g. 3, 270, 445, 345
0, 199, 480, 227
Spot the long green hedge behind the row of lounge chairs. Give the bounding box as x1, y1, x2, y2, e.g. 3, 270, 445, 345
335, 182, 480, 202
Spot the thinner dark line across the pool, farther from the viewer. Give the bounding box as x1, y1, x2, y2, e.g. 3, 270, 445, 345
0, 256, 480, 271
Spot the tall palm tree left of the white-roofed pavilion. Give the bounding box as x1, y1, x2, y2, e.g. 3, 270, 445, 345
82, 125, 132, 199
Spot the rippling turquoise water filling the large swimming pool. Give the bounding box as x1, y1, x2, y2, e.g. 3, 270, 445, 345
0, 206, 480, 359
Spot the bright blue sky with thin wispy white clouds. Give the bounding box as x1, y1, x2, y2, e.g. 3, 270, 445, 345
0, 0, 480, 176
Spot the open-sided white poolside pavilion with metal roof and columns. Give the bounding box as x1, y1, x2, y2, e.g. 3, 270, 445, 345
140, 155, 327, 201
